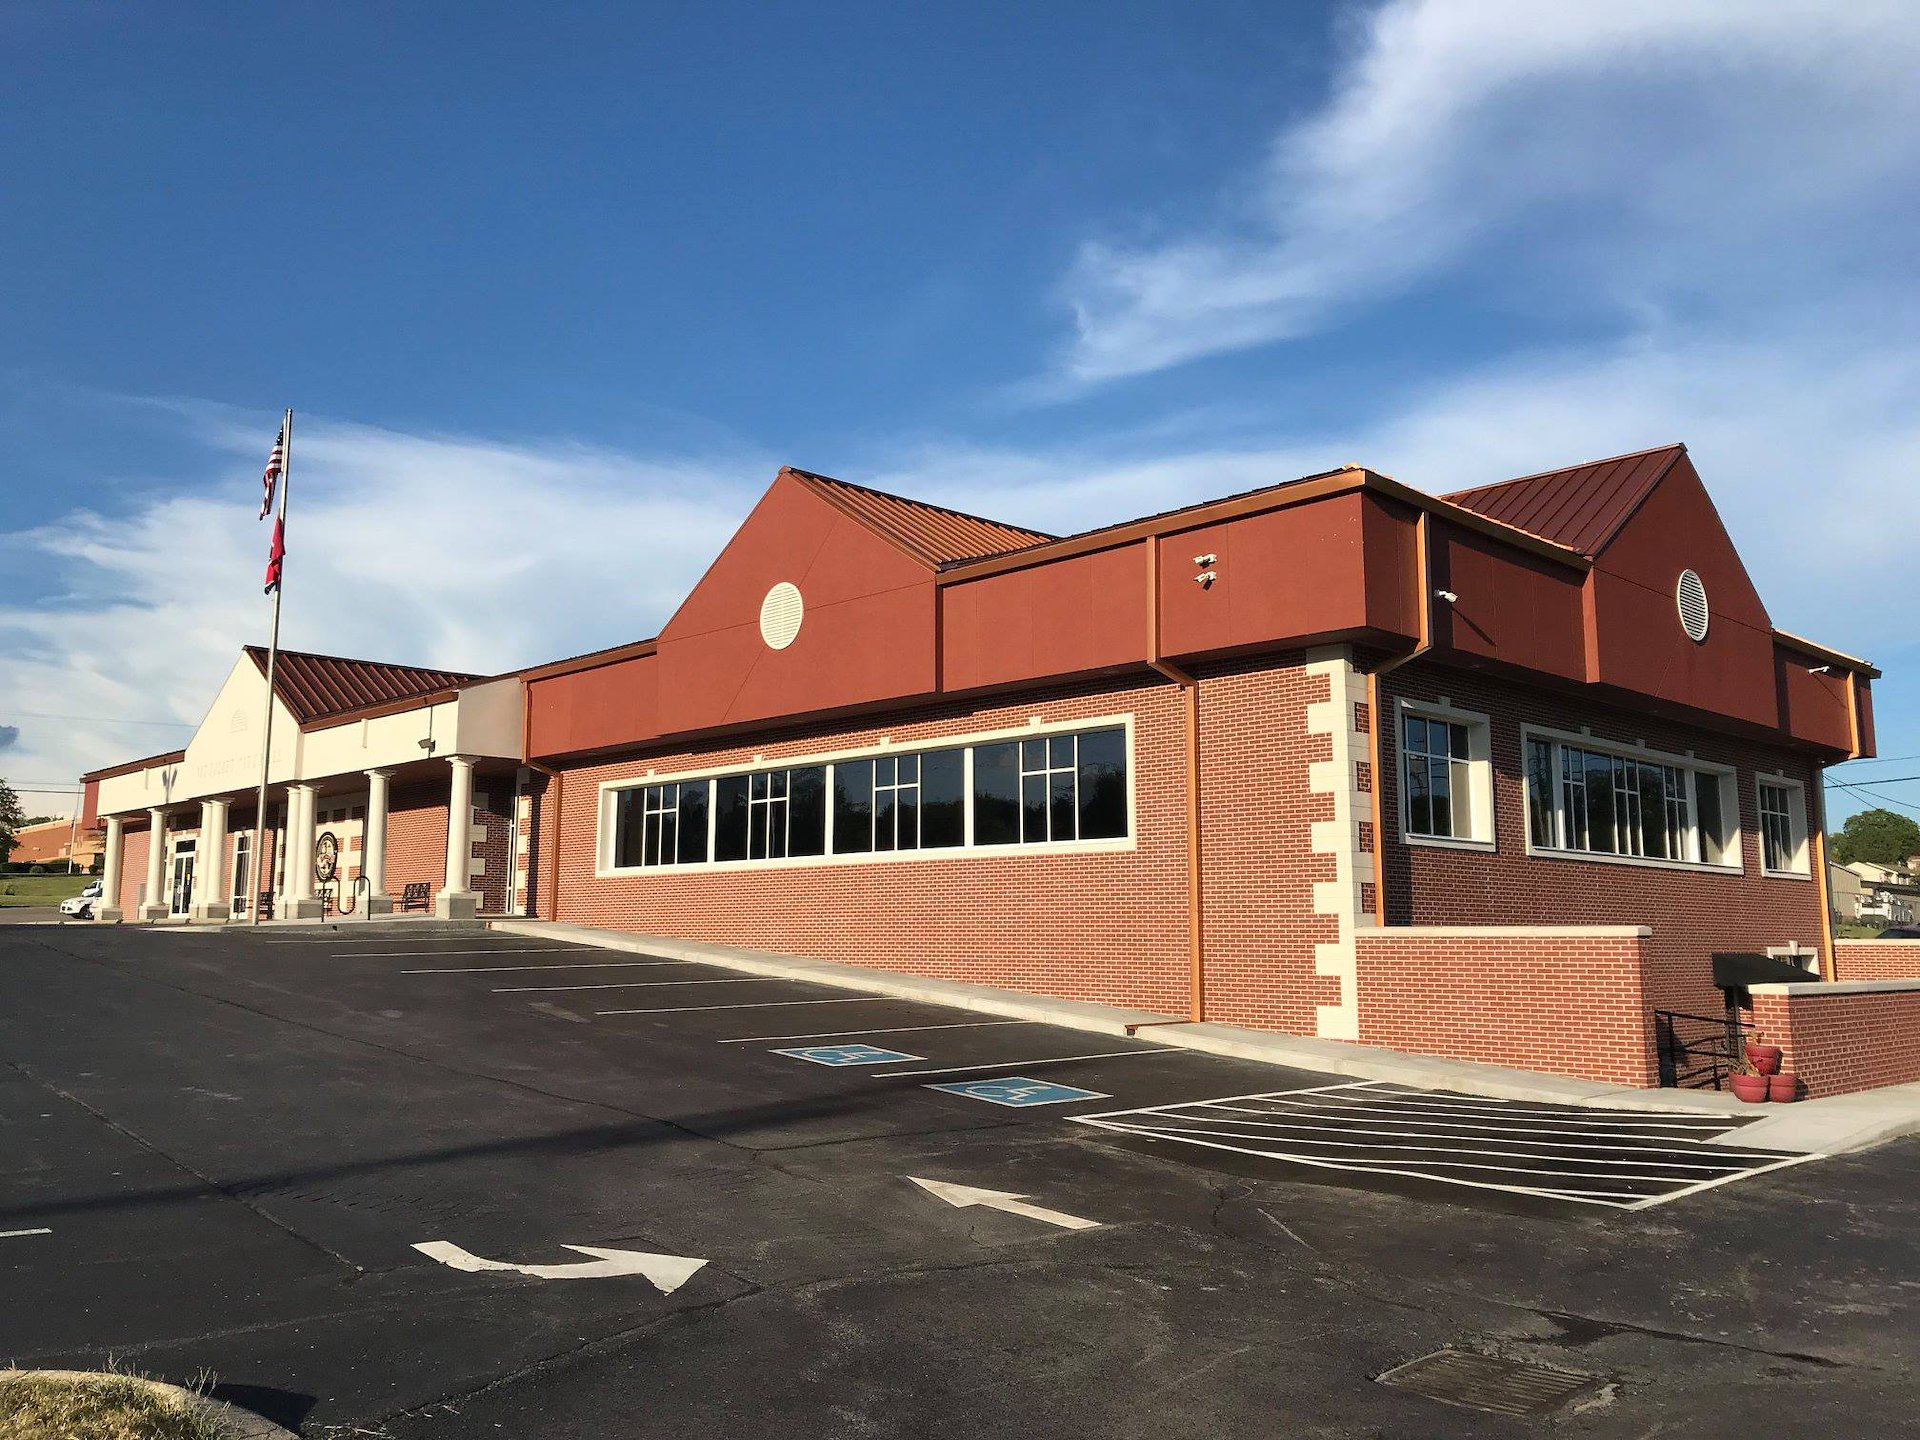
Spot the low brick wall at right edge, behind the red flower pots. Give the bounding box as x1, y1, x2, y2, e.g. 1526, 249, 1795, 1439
1753, 981, 1920, 1096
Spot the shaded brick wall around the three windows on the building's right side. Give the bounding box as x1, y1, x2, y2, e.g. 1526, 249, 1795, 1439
1380, 662, 1826, 1014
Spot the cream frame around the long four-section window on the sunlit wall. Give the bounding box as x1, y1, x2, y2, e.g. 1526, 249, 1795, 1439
593, 710, 1140, 879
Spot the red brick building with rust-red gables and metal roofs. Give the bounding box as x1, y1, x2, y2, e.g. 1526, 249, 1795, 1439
88, 445, 1878, 1085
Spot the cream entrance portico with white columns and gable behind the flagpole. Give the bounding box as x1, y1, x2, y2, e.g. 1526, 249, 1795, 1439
88, 651, 526, 924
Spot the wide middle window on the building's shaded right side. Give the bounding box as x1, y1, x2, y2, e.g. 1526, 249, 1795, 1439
1526, 735, 1740, 866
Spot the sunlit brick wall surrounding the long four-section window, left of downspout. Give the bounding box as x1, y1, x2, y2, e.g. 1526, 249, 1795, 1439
536, 680, 1190, 1014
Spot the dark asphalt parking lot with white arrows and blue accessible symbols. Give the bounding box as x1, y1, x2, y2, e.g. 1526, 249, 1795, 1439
0, 925, 1920, 1436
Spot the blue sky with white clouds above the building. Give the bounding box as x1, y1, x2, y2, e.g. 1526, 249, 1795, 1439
0, 0, 1920, 829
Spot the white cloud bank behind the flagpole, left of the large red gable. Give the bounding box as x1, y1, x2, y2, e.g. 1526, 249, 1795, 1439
0, 405, 776, 781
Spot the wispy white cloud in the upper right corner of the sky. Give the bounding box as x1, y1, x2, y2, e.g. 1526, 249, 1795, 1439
1064, 0, 1920, 384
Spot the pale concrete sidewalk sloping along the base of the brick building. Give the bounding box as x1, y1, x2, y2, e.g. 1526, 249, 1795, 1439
488, 920, 1920, 1154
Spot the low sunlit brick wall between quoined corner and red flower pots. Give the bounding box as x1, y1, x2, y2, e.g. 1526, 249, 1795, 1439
1357, 927, 1659, 1085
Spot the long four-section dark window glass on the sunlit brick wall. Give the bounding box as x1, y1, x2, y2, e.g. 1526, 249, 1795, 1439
601, 726, 1133, 870
